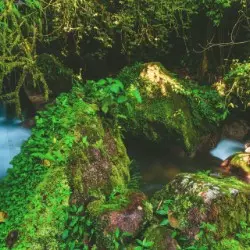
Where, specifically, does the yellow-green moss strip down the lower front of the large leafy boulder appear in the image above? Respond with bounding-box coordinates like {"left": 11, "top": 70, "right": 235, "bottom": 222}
{"left": 15, "top": 166, "right": 71, "bottom": 250}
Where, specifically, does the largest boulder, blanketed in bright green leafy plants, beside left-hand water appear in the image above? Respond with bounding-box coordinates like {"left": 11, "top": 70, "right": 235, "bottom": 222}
{"left": 0, "top": 87, "right": 130, "bottom": 250}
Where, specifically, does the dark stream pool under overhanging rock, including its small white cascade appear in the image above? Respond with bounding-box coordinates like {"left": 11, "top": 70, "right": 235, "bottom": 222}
{"left": 126, "top": 138, "right": 244, "bottom": 195}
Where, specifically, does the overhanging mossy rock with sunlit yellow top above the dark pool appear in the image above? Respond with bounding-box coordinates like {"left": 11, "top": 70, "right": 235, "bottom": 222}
{"left": 118, "top": 63, "right": 224, "bottom": 151}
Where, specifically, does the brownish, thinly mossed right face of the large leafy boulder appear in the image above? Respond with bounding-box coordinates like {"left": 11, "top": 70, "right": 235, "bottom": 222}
{"left": 68, "top": 117, "right": 130, "bottom": 202}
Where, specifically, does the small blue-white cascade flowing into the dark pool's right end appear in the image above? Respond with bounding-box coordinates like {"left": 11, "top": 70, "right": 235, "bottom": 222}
{"left": 210, "top": 139, "right": 244, "bottom": 160}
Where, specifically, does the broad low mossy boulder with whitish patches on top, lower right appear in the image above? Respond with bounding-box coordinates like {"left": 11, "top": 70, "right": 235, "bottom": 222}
{"left": 153, "top": 173, "right": 250, "bottom": 240}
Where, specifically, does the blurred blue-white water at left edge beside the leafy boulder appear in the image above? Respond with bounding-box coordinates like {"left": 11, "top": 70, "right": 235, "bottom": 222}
{"left": 0, "top": 104, "right": 31, "bottom": 178}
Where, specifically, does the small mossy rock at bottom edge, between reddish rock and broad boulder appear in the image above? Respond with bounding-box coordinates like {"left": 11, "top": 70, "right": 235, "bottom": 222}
{"left": 144, "top": 225, "right": 180, "bottom": 250}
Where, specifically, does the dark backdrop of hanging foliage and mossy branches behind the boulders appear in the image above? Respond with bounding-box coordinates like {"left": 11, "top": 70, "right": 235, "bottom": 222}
{"left": 0, "top": 0, "right": 250, "bottom": 113}
